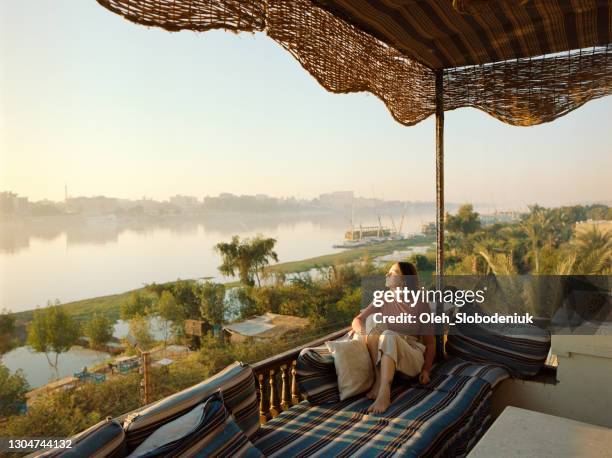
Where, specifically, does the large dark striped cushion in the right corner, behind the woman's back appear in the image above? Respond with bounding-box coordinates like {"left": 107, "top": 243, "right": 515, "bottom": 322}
{"left": 446, "top": 312, "right": 550, "bottom": 377}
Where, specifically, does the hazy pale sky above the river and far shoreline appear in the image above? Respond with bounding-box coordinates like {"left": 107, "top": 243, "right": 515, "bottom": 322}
{"left": 0, "top": 0, "right": 612, "bottom": 206}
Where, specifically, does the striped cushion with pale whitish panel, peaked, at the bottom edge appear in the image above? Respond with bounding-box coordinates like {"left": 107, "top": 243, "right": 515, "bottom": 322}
{"left": 130, "top": 393, "right": 263, "bottom": 458}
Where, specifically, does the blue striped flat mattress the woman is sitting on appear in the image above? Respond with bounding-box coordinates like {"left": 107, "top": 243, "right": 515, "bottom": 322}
{"left": 253, "top": 358, "right": 509, "bottom": 457}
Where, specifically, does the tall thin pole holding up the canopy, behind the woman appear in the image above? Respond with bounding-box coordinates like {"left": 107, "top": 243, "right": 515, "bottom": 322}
{"left": 436, "top": 70, "right": 444, "bottom": 360}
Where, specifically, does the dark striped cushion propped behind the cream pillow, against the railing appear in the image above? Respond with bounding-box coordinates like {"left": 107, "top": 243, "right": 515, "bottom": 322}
{"left": 296, "top": 346, "right": 340, "bottom": 405}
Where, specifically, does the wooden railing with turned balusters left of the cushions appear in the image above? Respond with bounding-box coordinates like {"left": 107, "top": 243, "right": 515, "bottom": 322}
{"left": 251, "top": 328, "right": 350, "bottom": 424}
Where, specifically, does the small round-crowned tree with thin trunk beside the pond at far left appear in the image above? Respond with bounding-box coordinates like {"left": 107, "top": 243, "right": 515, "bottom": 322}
{"left": 27, "top": 301, "right": 80, "bottom": 377}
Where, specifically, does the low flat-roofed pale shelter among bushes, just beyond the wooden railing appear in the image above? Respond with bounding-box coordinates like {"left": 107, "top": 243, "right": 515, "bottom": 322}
{"left": 223, "top": 312, "right": 309, "bottom": 343}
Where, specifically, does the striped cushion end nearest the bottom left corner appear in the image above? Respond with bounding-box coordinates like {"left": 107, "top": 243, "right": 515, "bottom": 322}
{"left": 30, "top": 419, "right": 125, "bottom": 458}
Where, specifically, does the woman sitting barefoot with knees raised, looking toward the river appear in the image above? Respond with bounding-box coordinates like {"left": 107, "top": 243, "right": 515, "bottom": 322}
{"left": 352, "top": 262, "right": 436, "bottom": 413}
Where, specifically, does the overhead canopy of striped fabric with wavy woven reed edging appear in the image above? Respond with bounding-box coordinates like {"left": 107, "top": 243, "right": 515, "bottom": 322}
{"left": 97, "top": 0, "right": 612, "bottom": 126}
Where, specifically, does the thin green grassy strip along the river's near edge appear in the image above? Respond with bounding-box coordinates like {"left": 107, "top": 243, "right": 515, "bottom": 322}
{"left": 14, "top": 237, "right": 433, "bottom": 325}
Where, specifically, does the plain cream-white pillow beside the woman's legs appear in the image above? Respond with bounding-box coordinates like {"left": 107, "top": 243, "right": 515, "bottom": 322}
{"left": 325, "top": 340, "right": 374, "bottom": 401}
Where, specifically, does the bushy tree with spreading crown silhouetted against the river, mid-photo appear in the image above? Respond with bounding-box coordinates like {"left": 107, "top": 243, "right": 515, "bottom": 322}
{"left": 215, "top": 235, "right": 278, "bottom": 286}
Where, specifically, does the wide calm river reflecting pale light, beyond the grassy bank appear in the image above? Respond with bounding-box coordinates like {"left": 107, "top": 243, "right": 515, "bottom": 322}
{"left": 0, "top": 210, "right": 434, "bottom": 312}
